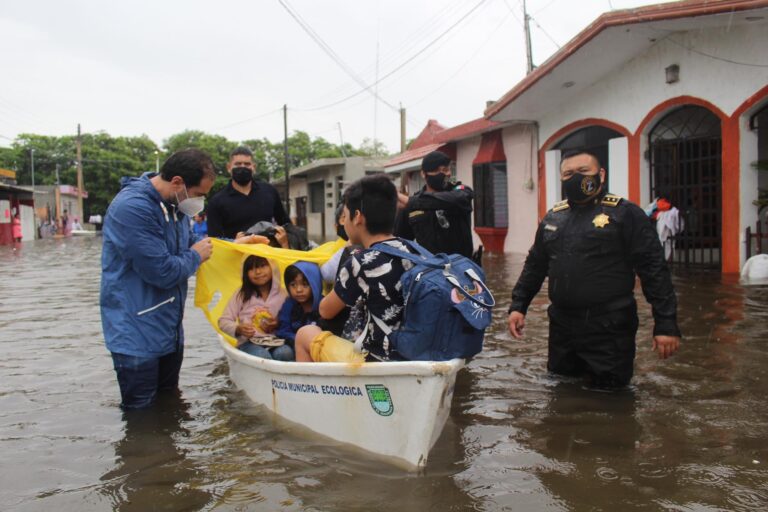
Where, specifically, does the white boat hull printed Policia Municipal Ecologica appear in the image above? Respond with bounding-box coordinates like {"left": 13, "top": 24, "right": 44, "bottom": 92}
{"left": 219, "top": 336, "right": 464, "bottom": 470}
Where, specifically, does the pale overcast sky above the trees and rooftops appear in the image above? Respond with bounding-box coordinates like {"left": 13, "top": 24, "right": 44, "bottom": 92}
{"left": 0, "top": 0, "right": 672, "bottom": 151}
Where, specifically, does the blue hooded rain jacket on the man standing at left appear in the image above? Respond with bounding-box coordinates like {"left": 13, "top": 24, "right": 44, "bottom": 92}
{"left": 100, "top": 173, "right": 200, "bottom": 357}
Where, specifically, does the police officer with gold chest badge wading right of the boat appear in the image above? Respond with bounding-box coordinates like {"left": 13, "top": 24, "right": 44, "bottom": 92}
{"left": 509, "top": 152, "right": 680, "bottom": 388}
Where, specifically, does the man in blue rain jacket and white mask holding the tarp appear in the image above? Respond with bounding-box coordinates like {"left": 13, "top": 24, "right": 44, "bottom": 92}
{"left": 100, "top": 149, "right": 216, "bottom": 409}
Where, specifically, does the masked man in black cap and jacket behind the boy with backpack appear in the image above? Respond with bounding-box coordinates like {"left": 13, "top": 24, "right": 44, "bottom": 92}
{"left": 395, "top": 151, "right": 475, "bottom": 258}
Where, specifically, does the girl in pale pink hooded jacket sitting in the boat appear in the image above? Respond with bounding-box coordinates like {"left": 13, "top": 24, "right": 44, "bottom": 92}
{"left": 219, "top": 255, "right": 294, "bottom": 361}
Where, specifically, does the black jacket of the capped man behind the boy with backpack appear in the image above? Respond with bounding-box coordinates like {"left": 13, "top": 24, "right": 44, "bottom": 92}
{"left": 395, "top": 184, "right": 475, "bottom": 258}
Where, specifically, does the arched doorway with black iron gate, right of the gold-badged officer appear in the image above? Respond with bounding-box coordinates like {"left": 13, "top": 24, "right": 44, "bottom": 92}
{"left": 649, "top": 105, "right": 722, "bottom": 268}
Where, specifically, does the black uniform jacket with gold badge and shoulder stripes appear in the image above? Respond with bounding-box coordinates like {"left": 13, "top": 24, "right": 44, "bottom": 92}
{"left": 510, "top": 194, "right": 680, "bottom": 336}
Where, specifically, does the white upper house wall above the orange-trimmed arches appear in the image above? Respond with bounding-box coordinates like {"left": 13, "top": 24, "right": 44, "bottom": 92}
{"left": 538, "top": 24, "right": 768, "bottom": 143}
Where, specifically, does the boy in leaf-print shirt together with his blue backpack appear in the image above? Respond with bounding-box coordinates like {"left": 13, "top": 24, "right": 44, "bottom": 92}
{"left": 296, "top": 174, "right": 494, "bottom": 362}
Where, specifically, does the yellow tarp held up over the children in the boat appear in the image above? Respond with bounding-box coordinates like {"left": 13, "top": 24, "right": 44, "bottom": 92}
{"left": 195, "top": 238, "right": 344, "bottom": 346}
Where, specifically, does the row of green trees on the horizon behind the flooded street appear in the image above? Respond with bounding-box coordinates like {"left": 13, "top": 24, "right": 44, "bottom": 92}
{"left": 0, "top": 130, "right": 387, "bottom": 218}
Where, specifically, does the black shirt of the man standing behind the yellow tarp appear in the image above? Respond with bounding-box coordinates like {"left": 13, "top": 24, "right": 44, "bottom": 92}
{"left": 208, "top": 181, "right": 290, "bottom": 238}
